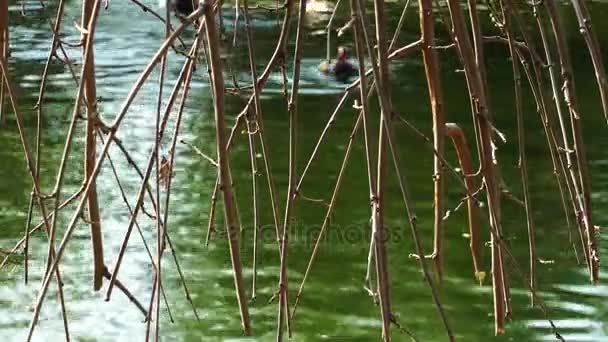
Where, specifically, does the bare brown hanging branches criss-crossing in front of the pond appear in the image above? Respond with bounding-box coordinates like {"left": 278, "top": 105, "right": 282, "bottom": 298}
{"left": 0, "top": 0, "right": 608, "bottom": 341}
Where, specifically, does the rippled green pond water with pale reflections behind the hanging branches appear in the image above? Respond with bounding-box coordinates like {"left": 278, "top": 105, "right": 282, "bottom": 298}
{"left": 0, "top": 0, "right": 608, "bottom": 341}
